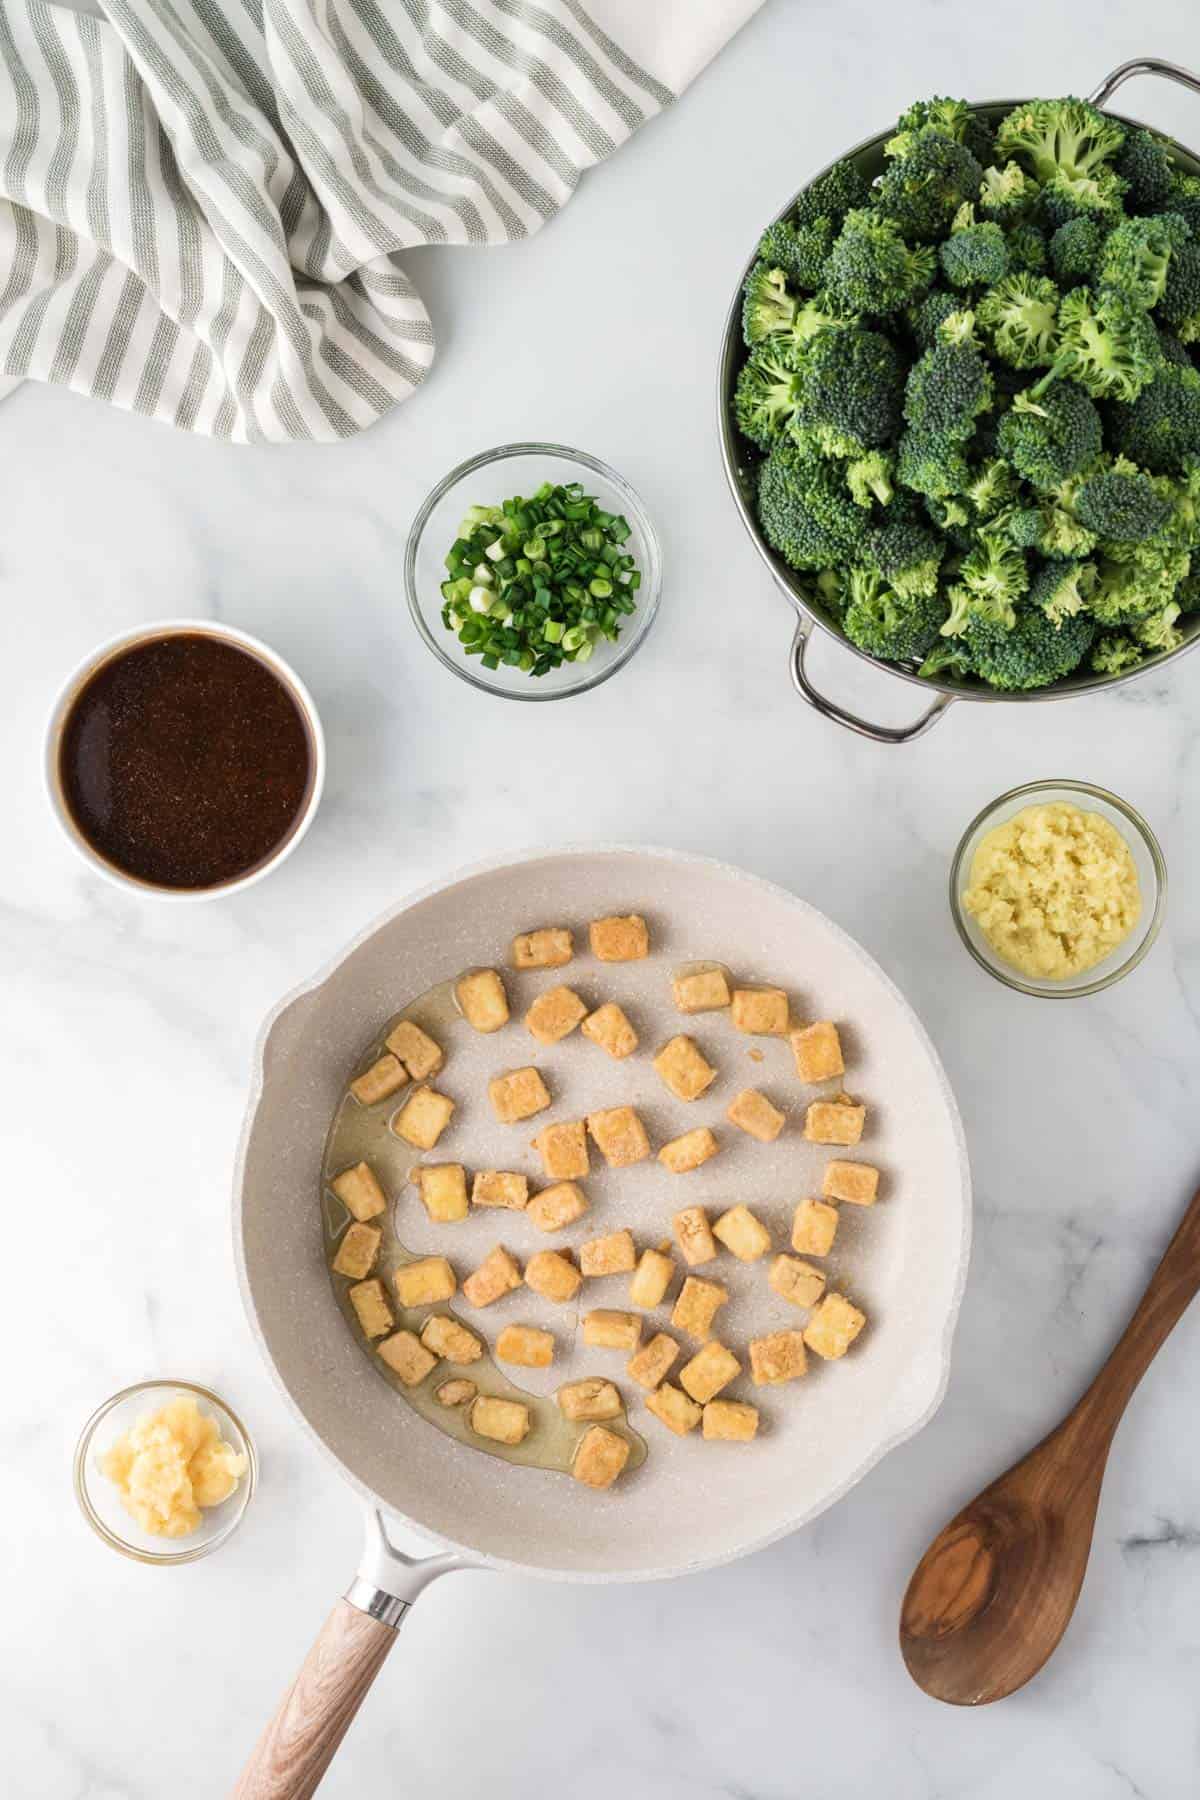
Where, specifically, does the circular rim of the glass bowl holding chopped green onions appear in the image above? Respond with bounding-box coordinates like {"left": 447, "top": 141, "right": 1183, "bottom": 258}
{"left": 405, "top": 439, "right": 662, "bottom": 702}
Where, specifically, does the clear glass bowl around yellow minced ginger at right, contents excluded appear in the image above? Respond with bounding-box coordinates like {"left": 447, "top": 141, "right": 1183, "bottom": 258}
{"left": 950, "top": 781, "right": 1166, "bottom": 1001}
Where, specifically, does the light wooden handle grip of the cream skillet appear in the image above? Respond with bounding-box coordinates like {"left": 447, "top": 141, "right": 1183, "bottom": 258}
{"left": 230, "top": 1600, "right": 396, "bottom": 1800}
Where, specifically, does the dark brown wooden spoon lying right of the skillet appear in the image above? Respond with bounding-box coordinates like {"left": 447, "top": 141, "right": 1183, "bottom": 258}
{"left": 900, "top": 1193, "right": 1200, "bottom": 1706}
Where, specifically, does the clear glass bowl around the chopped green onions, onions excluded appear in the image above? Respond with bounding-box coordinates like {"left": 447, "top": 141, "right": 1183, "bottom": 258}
{"left": 405, "top": 443, "right": 662, "bottom": 700}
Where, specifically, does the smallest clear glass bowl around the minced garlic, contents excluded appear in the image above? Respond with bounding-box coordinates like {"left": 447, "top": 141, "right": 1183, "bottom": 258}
{"left": 74, "top": 1381, "right": 259, "bottom": 1564}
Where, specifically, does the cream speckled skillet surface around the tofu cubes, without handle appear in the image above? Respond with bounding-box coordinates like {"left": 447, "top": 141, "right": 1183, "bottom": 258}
{"left": 236, "top": 850, "right": 970, "bottom": 1579}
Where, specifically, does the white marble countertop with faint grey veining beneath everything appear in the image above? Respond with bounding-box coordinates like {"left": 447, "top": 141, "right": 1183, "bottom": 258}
{"left": 0, "top": 0, "right": 1200, "bottom": 1800}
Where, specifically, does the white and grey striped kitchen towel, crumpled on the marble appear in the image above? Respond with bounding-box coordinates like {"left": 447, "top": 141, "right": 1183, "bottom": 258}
{"left": 0, "top": 0, "right": 761, "bottom": 443}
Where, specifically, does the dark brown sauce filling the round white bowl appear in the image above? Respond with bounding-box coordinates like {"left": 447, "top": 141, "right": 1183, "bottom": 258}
{"left": 59, "top": 632, "right": 313, "bottom": 889}
